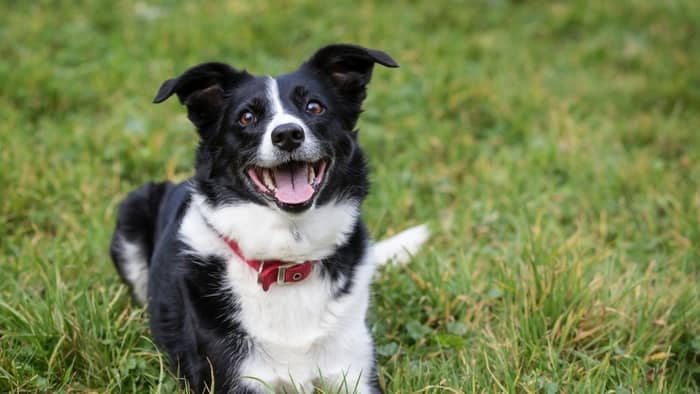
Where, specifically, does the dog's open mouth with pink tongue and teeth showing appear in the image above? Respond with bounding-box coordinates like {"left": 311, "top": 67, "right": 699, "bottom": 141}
{"left": 248, "top": 160, "right": 326, "bottom": 205}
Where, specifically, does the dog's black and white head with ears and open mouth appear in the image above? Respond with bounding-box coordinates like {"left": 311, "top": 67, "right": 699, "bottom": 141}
{"left": 154, "top": 45, "right": 397, "bottom": 213}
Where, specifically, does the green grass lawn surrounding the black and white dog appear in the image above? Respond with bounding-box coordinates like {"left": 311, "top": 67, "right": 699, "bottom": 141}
{"left": 0, "top": 0, "right": 700, "bottom": 393}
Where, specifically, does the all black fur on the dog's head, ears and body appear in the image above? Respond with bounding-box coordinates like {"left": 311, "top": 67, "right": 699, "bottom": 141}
{"left": 111, "top": 45, "right": 397, "bottom": 393}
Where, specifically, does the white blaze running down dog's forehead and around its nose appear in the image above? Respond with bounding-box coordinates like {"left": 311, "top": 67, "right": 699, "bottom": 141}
{"left": 259, "top": 77, "right": 316, "bottom": 162}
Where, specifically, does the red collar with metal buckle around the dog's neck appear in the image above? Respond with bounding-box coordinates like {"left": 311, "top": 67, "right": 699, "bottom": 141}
{"left": 223, "top": 237, "right": 315, "bottom": 291}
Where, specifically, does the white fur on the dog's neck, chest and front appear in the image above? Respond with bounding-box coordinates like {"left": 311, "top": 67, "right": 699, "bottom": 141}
{"left": 180, "top": 194, "right": 375, "bottom": 392}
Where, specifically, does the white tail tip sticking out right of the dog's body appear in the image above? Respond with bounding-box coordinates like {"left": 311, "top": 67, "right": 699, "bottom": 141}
{"left": 372, "top": 224, "right": 430, "bottom": 265}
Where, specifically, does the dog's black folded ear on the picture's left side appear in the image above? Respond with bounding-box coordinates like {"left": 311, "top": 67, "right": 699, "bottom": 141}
{"left": 153, "top": 62, "right": 250, "bottom": 130}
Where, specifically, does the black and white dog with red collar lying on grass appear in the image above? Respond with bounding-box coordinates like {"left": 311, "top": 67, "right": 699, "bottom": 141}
{"left": 111, "top": 45, "right": 428, "bottom": 393}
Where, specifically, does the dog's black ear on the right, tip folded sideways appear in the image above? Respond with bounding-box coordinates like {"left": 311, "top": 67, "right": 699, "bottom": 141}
{"left": 307, "top": 44, "right": 399, "bottom": 102}
